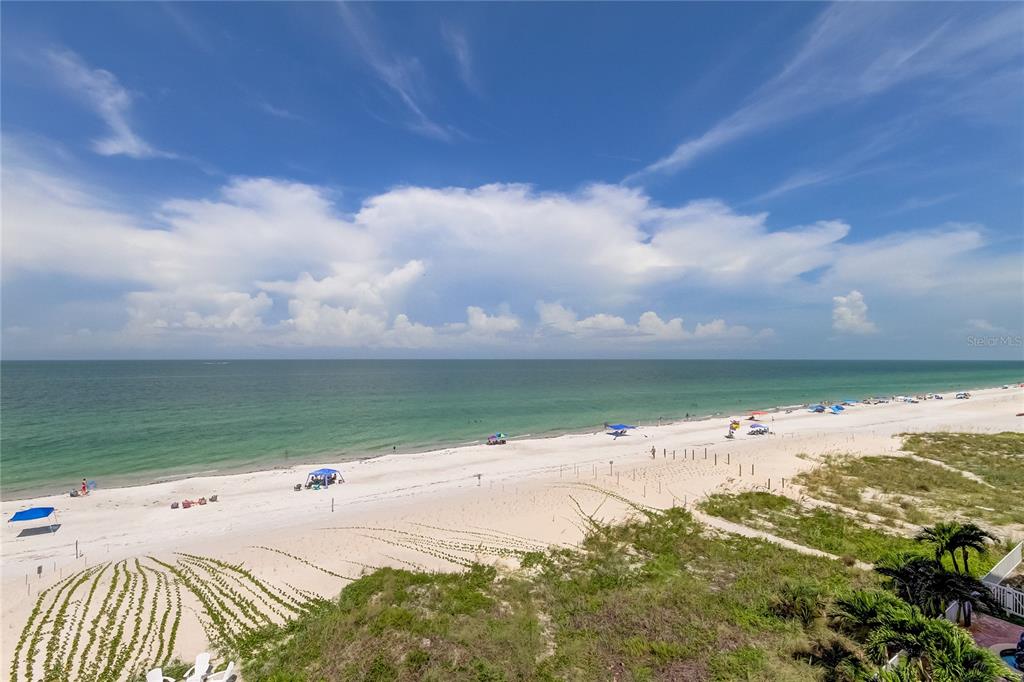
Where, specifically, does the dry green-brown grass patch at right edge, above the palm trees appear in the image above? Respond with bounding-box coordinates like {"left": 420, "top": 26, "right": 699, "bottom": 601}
{"left": 794, "top": 433, "right": 1024, "bottom": 530}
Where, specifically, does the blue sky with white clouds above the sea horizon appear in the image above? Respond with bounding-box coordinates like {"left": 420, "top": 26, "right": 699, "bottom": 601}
{"left": 0, "top": 2, "right": 1024, "bottom": 359}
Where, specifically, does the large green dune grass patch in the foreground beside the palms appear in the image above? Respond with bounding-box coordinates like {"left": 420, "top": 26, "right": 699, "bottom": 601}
{"left": 246, "top": 509, "right": 876, "bottom": 682}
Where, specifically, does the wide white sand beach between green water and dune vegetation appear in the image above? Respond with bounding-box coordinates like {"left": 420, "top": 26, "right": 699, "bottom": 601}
{"left": 0, "top": 387, "right": 1024, "bottom": 671}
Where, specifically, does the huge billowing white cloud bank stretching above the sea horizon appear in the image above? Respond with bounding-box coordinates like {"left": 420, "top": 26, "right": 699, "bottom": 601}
{"left": 2, "top": 146, "right": 1021, "bottom": 356}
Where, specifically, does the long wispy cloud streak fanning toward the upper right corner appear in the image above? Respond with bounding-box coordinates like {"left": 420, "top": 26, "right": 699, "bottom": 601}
{"left": 628, "top": 3, "right": 1022, "bottom": 179}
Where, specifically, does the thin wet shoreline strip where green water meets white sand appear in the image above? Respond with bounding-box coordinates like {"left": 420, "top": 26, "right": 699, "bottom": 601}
{"left": 0, "top": 376, "right": 1016, "bottom": 502}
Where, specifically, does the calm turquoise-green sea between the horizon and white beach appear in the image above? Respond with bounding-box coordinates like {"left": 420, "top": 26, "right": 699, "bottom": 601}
{"left": 0, "top": 360, "right": 1024, "bottom": 497}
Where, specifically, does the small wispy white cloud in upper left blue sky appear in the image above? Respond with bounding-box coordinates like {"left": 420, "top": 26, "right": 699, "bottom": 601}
{"left": 45, "top": 50, "right": 174, "bottom": 159}
